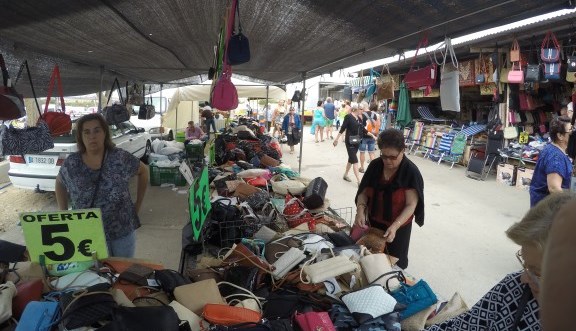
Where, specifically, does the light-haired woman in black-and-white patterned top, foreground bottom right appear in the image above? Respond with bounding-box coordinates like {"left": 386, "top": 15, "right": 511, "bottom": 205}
{"left": 426, "top": 193, "right": 575, "bottom": 331}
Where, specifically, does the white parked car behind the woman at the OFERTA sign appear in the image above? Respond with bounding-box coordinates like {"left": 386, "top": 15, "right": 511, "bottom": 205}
{"left": 8, "top": 121, "right": 152, "bottom": 192}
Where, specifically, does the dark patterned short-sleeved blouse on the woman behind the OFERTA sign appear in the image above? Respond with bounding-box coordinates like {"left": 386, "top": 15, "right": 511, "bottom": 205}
{"left": 60, "top": 148, "right": 140, "bottom": 240}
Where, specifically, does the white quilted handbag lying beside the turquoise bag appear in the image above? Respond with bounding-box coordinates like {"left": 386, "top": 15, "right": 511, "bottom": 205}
{"left": 340, "top": 285, "right": 402, "bottom": 324}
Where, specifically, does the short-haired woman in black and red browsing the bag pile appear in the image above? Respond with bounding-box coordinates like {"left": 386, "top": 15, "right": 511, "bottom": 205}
{"left": 355, "top": 129, "right": 424, "bottom": 268}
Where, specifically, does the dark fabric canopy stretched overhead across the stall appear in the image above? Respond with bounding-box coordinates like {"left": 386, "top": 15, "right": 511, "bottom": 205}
{"left": 0, "top": 0, "right": 569, "bottom": 97}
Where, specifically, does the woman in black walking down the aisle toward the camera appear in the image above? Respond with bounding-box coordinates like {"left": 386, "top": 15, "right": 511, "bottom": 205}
{"left": 334, "top": 105, "right": 376, "bottom": 185}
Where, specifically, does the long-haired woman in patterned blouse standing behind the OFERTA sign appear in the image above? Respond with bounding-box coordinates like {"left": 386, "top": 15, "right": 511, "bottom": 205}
{"left": 56, "top": 114, "right": 148, "bottom": 257}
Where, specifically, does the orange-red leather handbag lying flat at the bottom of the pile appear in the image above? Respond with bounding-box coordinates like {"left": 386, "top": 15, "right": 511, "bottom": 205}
{"left": 202, "top": 303, "right": 262, "bottom": 326}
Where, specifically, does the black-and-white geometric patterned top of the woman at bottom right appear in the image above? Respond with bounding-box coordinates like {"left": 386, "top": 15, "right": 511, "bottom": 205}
{"left": 426, "top": 272, "right": 542, "bottom": 331}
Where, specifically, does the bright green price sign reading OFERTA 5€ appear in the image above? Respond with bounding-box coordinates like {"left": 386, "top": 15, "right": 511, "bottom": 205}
{"left": 20, "top": 209, "right": 108, "bottom": 264}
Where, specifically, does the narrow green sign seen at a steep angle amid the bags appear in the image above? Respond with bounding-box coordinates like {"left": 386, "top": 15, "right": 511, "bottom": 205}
{"left": 188, "top": 167, "right": 212, "bottom": 241}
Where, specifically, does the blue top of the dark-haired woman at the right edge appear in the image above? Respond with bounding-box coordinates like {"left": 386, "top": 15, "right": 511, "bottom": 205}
{"left": 530, "top": 144, "right": 572, "bottom": 207}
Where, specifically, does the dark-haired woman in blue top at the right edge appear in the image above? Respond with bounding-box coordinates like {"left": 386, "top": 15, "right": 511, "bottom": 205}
{"left": 530, "top": 117, "right": 572, "bottom": 207}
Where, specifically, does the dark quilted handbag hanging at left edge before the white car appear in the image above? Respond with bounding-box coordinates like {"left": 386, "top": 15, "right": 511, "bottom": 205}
{"left": 0, "top": 120, "right": 54, "bottom": 155}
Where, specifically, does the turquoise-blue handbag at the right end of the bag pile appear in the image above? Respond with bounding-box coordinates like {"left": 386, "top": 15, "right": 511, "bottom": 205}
{"left": 390, "top": 279, "right": 438, "bottom": 320}
